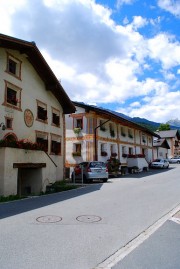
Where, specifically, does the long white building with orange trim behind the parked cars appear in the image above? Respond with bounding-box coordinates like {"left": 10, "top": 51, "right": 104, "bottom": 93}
{"left": 66, "top": 102, "right": 158, "bottom": 174}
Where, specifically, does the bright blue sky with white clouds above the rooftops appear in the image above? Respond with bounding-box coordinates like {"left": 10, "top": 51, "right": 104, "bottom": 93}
{"left": 0, "top": 0, "right": 180, "bottom": 123}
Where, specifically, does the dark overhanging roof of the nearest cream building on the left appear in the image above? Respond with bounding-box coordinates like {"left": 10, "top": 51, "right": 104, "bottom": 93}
{"left": 0, "top": 34, "right": 75, "bottom": 114}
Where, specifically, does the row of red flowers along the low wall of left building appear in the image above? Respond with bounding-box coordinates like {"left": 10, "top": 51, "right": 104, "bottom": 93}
{"left": 0, "top": 139, "right": 45, "bottom": 150}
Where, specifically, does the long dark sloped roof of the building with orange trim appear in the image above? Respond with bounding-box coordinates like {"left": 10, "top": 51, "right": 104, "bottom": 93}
{"left": 73, "top": 101, "right": 159, "bottom": 137}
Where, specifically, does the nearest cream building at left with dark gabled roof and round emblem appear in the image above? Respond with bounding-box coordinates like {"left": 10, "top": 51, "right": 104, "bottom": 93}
{"left": 0, "top": 34, "right": 75, "bottom": 195}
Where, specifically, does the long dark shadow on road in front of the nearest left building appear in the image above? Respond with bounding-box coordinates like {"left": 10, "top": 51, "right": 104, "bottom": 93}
{"left": 0, "top": 183, "right": 103, "bottom": 219}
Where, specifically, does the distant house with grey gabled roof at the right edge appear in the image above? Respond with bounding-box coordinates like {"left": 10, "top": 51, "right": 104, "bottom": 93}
{"left": 156, "top": 130, "right": 180, "bottom": 158}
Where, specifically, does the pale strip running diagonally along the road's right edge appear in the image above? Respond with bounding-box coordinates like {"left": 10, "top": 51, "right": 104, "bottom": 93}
{"left": 94, "top": 204, "right": 180, "bottom": 269}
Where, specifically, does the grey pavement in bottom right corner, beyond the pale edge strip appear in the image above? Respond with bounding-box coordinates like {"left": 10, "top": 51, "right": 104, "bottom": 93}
{"left": 111, "top": 211, "right": 180, "bottom": 269}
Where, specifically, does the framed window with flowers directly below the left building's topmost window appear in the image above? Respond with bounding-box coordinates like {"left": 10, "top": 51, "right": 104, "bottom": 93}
{"left": 3, "top": 81, "right": 21, "bottom": 109}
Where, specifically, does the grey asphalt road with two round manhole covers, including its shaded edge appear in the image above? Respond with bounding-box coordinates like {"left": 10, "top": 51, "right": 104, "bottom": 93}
{"left": 0, "top": 165, "right": 180, "bottom": 269}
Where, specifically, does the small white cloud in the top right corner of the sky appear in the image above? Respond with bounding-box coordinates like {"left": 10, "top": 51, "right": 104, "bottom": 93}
{"left": 158, "top": 0, "right": 180, "bottom": 18}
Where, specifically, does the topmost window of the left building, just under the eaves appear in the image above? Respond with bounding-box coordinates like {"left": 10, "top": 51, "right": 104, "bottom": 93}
{"left": 6, "top": 53, "right": 21, "bottom": 79}
